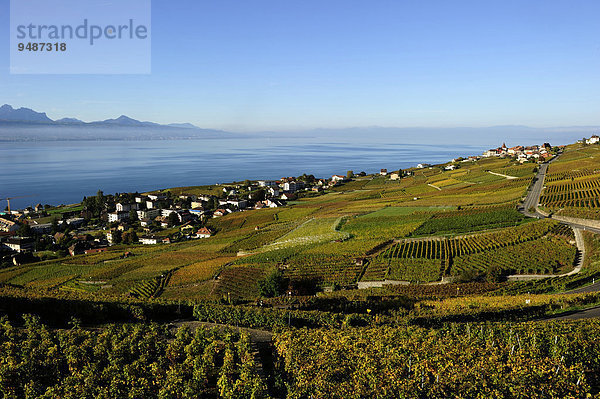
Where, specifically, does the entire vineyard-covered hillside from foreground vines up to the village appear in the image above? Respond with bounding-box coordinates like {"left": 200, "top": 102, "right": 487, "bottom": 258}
{"left": 5, "top": 144, "right": 600, "bottom": 398}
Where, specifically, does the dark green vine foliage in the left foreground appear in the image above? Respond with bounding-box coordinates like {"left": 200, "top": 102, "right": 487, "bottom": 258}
{"left": 0, "top": 316, "right": 268, "bottom": 399}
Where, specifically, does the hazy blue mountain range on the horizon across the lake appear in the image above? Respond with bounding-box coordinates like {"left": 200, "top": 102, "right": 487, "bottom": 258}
{"left": 0, "top": 104, "right": 600, "bottom": 145}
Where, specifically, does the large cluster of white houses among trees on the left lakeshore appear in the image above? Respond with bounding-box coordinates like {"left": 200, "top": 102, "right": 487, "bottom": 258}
{"left": 0, "top": 175, "right": 360, "bottom": 256}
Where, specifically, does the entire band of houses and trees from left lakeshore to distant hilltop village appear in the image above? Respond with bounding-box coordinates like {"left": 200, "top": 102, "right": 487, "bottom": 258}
{"left": 0, "top": 135, "right": 580, "bottom": 266}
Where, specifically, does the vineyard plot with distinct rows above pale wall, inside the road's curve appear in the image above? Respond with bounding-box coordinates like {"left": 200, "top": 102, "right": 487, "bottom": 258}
{"left": 363, "top": 219, "right": 576, "bottom": 282}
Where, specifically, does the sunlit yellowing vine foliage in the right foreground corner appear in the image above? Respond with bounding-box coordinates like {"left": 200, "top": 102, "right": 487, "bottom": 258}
{"left": 275, "top": 320, "right": 600, "bottom": 399}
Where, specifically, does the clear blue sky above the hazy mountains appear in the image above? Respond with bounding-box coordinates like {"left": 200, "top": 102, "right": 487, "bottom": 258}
{"left": 0, "top": 0, "right": 600, "bottom": 131}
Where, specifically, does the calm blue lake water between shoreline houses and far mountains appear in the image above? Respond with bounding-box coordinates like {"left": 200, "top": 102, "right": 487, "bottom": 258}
{"left": 0, "top": 138, "right": 485, "bottom": 209}
